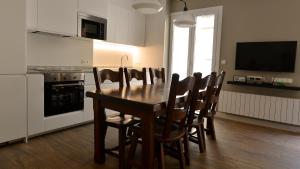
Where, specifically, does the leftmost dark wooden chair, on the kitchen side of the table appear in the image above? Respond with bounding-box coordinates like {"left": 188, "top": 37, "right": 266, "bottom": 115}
{"left": 93, "top": 67, "right": 136, "bottom": 168}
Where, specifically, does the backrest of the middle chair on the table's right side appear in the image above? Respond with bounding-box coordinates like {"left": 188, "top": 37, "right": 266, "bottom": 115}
{"left": 187, "top": 72, "right": 216, "bottom": 126}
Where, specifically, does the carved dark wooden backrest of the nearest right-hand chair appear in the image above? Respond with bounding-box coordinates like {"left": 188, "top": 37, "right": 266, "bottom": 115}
{"left": 163, "top": 74, "right": 195, "bottom": 138}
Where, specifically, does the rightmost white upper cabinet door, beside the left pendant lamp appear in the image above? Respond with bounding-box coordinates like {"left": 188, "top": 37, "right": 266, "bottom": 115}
{"left": 128, "top": 9, "right": 145, "bottom": 46}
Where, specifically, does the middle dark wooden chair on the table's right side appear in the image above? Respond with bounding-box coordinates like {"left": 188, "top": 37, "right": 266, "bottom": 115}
{"left": 187, "top": 72, "right": 216, "bottom": 153}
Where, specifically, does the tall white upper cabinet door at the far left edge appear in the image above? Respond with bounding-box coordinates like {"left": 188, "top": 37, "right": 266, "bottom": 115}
{"left": 0, "top": 0, "right": 26, "bottom": 74}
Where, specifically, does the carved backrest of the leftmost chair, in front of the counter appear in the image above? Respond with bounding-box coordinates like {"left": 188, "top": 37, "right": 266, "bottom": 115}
{"left": 93, "top": 67, "right": 123, "bottom": 91}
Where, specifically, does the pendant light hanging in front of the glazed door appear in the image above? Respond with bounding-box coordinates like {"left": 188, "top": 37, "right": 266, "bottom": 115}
{"left": 174, "top": 0, "right": 196, "bottom": 28}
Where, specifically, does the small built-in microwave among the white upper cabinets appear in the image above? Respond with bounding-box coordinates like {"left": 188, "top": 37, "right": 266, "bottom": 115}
{"left": 78, "top": 13, "right": 107, "bottom": 40}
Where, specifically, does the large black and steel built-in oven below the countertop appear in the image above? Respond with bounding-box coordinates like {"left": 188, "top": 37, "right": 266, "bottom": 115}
{"left": 44, "top": 73, "right": 84, "bottom": 117}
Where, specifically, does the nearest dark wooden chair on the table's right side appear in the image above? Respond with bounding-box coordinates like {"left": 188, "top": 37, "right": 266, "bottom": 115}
{"left": 128, "top": 74, "right": 195, "bottom": 169}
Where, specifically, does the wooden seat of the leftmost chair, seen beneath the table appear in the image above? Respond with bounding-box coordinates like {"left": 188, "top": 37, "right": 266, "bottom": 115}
{"left": 106, "top": 115, "right": 140, "bottom": 128}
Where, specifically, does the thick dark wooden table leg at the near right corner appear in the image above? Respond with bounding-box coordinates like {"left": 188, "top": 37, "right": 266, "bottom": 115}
{"left": 142, "top": 113, "right": 155, "bottom": 169}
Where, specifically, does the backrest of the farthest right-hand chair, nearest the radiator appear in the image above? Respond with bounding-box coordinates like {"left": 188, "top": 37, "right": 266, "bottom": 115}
{"left": 211, "top": 71, "right": 226, "bottom": 113}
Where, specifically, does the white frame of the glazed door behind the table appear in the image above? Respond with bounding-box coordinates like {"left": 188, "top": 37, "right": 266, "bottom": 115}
{"left": 168, "top": 6, "right": 223, "bottom": 78}
